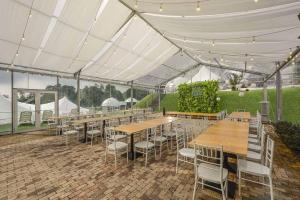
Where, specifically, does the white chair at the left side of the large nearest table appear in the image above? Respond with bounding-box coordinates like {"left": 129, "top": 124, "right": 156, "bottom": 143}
{"left": 175, "top": 128, "right": 195, "bottom": 174}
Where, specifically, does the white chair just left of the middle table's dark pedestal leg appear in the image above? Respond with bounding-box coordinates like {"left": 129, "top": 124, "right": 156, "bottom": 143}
{"left": 105, "top": 129, "right": 128, "bottom": 168}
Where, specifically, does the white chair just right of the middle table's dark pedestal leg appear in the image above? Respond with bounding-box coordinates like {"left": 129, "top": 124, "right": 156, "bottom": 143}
{"left": 134, "top": 128, "right": 156, "bottom": 167}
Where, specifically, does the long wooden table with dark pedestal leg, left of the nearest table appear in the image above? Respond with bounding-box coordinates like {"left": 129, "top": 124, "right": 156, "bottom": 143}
{"left": 114, "top": 117, "right": 177, "bottom": 160}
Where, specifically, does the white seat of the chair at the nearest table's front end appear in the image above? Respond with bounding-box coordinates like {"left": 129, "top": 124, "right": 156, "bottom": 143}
{"left": 198, "top": 163, "right": 228, "bottom": 183}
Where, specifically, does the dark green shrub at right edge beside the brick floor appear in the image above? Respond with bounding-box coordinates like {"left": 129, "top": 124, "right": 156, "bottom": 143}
{"left": 275, "top": 121, "right": 300, "bottom": 151}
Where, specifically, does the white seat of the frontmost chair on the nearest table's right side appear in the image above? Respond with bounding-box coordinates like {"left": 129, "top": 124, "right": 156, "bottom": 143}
{"left": 238, "top": 159, "right": 270, "bottom": 176}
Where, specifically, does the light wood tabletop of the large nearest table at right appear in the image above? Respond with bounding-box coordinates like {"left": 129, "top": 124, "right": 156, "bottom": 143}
{"left": 189, "top": 119, "right": 249, "bottom": 156}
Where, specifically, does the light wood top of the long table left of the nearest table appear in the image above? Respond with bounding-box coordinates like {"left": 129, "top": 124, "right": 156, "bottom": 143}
{"left": 114, "top": 117, "right": 177, "bottom": 135}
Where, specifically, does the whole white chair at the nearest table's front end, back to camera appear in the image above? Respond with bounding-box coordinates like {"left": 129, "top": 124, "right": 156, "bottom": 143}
{"left": 193, "top": 145, "right": 228, "bottom": 200}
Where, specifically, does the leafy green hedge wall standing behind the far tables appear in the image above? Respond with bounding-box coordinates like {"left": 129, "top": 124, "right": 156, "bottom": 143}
{"left": 178, "top": 81, "right": 220, "bottom": 113}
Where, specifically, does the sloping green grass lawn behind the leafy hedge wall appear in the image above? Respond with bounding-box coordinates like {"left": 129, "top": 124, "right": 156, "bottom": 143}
{"left": 161, "top": 87, "right": 300, "bottom": 124}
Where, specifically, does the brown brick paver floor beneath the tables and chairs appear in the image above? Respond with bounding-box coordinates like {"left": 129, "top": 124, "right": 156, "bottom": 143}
{"left": 0, "top": 126, "right": 300, "bottom": 200}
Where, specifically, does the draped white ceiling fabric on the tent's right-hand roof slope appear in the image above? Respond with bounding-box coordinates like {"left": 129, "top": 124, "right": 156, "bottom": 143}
{"left": 124, "top": 0, "right": 300, "bottom": 76}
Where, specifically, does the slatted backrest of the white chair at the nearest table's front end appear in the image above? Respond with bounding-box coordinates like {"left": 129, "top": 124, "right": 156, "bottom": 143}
{"left": 194, "top": 145, "right": 223, "bottom": 182}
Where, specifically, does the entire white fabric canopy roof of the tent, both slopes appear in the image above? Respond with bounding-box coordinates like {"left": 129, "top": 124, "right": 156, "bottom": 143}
{"left": 0, "top": 0, "right": 300, "bottom": 86}
